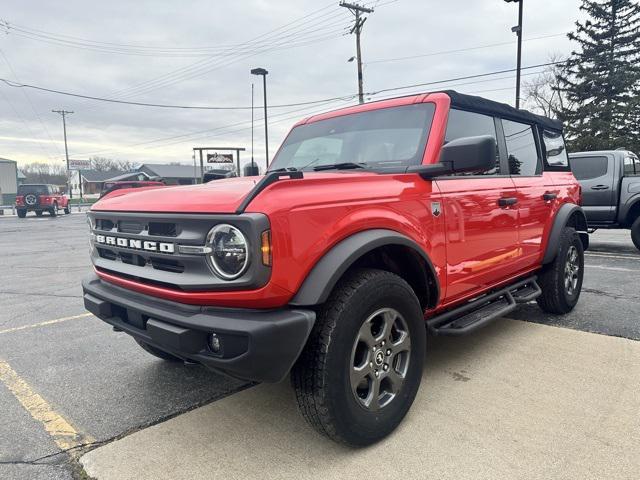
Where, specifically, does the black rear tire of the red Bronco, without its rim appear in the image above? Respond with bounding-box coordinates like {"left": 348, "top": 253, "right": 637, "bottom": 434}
{"left": 536, "top": 227, "right": 584, "bottom": 315}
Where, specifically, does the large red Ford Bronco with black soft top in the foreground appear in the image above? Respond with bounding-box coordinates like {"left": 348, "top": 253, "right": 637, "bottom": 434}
{"left": 83, "top": 92, "right": 589, "bottom": 446}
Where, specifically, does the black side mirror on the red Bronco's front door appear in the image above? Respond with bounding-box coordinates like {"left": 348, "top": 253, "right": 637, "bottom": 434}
{"left": 407, "top": 135, "right": 496, "bottom": 179}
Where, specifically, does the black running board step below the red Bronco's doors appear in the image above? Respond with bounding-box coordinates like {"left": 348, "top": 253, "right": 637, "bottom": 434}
{"left": 427, "top": 276, "right": 542, "bottom": 336}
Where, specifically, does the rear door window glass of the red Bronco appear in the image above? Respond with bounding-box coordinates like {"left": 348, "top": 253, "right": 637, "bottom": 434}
{"left": 502, "top": 120, "right": 541, "bottom": 177}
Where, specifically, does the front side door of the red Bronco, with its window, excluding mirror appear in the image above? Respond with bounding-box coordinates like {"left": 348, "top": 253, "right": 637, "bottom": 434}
{"left": 436, "top": 109, "right": 522, "bottom": 303}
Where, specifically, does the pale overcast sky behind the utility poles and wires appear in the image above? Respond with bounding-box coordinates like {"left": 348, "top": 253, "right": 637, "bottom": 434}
{"left": 0, "top": 0, "right": 580, "bottom": 170}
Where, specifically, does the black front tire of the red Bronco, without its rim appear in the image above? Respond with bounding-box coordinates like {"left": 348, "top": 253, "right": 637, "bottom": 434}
{"left": 291, "top": 269, "right": 426, "bottom": 446}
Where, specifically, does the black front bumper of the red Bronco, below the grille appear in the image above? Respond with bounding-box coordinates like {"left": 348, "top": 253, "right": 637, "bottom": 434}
{"left": 82, "top": 274, "right": 315, "bottom": 382}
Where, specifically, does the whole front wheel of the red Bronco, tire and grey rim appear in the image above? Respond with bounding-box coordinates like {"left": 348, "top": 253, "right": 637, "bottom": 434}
{"left": 291, "top": 269, "right": 426, "bottom": 446}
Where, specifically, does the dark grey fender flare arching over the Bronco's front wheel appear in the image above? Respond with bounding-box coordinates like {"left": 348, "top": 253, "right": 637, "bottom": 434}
{"left": 289, "top": 229, "right": 440, "bottom": 306}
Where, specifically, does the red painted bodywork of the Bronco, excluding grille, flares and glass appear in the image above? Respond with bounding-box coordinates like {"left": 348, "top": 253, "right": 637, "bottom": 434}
{"left": 93, "top": 93, "right": 579, "bottom": 313}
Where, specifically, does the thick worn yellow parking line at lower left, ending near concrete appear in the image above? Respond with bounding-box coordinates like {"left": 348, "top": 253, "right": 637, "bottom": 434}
{"left": 0, "top": 360, "right": 93, "bottom": 455}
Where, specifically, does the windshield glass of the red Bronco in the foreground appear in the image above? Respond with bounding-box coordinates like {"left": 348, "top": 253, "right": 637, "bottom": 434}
{"left": 269, "top": 103, "right": 435, "bottom": 170}
